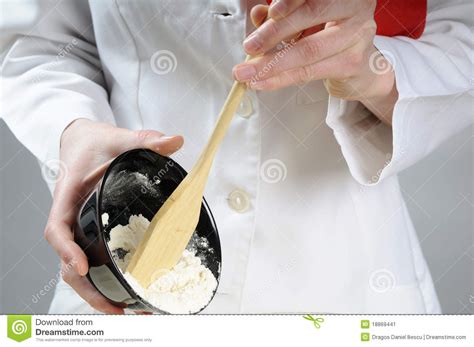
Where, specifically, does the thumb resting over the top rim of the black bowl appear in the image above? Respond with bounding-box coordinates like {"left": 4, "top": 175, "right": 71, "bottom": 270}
{"left": 112, "top": 128, "right": 184, "bottom": 155}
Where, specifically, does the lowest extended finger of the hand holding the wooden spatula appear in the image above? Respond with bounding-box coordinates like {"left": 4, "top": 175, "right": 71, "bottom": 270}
{"left": 249, "top": 47, "right": 363, "bottom": 90}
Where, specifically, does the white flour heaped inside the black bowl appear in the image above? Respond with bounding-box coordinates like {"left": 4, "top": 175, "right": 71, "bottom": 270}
{"left": 102, "top": 213, "right": 217, "bottom": 314}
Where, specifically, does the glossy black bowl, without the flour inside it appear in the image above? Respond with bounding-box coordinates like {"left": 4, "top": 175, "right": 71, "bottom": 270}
{"left": 74, "top": 149, "right": 222, "bottom": 314}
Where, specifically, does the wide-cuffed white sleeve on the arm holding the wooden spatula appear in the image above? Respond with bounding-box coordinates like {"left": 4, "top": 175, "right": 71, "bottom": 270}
{"left": 327, "top": 0, "right": 474, "bottom": 185}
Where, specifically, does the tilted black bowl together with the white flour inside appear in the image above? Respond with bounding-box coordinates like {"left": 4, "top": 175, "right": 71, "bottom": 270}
{"left": 74, "top": 149, "right": 222, "bottom": 314}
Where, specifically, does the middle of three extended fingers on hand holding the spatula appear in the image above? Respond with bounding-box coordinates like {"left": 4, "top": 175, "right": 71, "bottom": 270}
{"left": 233, "top": 25, "right": 358, "bottom": 82}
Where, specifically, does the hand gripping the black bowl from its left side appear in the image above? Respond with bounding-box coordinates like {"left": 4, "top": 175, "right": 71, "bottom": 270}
{"left": 45, "top": 119, "right": 183, "bottom": 314}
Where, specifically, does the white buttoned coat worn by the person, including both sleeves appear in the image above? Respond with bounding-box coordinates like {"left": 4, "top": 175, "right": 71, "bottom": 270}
{"left": 2, "top": 0, "right": 473, "bottom": 313}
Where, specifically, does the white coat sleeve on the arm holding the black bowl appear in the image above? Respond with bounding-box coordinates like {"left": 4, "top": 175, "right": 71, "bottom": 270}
{"left": 0, "top": 0, "right": 114, "bottom": 169}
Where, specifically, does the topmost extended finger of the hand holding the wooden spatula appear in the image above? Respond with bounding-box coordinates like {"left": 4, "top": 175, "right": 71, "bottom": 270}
{"left": 244, "top": 0, "right": 360, "bottom": 55}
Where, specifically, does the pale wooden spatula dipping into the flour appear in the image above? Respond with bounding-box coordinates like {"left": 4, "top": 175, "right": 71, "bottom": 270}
{"left": 127, "top": 56, "right": 250, "bottom": 288}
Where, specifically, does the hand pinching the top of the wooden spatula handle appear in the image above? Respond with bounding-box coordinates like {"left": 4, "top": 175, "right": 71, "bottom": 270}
{"left": 233, "top": 0, "right": 398, "bottom": 123}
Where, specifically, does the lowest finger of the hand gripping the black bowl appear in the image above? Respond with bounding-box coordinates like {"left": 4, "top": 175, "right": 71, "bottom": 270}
{"left": 62, "top": 267, "right": 124, "bottom": 314}
